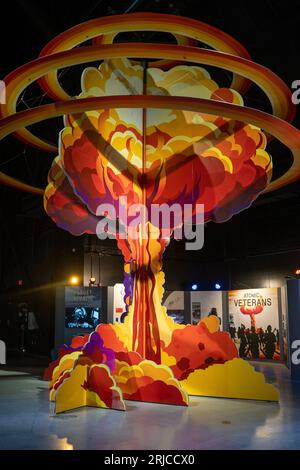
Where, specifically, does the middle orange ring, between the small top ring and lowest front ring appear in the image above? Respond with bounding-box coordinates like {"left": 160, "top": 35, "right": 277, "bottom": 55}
{"left": 0, "top": 43, "right": 295, "bottom": 152}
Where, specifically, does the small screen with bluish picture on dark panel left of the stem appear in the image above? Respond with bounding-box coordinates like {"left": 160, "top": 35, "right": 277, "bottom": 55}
{"left": 65, "top": 306, "right": 101, "bottom": 328}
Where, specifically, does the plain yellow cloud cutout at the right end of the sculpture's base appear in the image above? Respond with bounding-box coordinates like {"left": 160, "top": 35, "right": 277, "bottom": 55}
{"left": 181, "top": 359, "right": 279, "bottom": 401}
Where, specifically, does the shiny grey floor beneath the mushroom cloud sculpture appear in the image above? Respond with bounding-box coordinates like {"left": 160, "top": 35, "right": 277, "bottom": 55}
{"left": 0, "top": 364, "right": 300, "bottom": 450}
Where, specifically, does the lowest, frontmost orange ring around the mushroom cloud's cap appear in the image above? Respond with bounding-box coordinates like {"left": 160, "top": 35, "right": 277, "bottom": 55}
{"left": 0, "top": 95, "right": 300, "bottom": 194}
